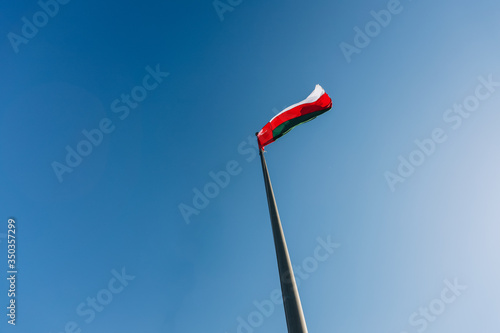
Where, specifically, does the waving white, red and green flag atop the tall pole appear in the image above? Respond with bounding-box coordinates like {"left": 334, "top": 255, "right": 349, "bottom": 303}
{"left": 257, "top": 84, "right": 332, "bottom": 149}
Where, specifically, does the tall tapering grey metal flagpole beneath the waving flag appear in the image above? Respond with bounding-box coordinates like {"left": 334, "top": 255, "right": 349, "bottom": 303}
{"left": 259, "top": 145, "right": 308, "bottom": 333}
